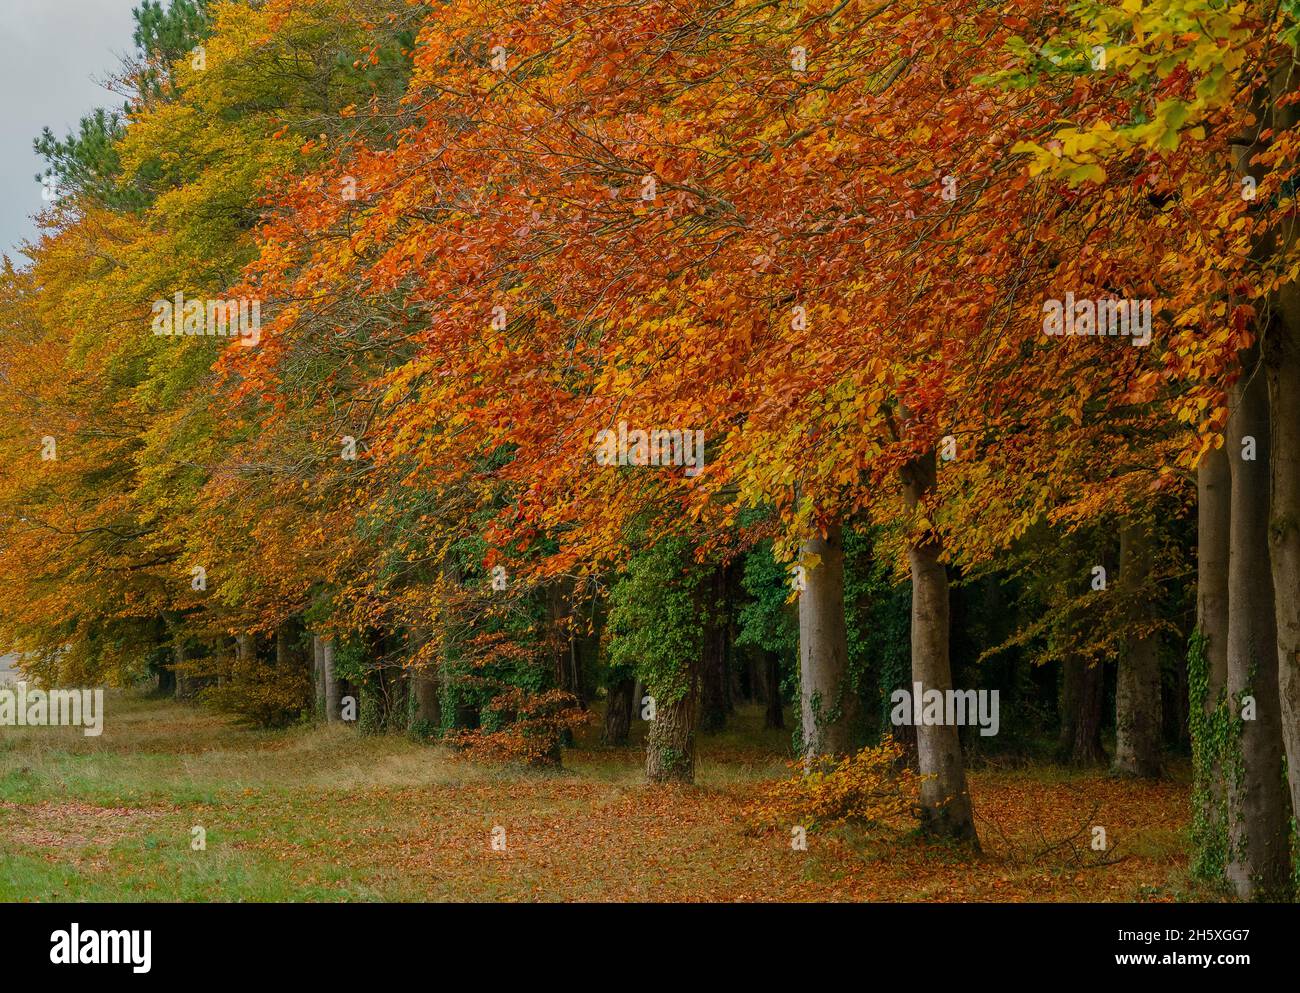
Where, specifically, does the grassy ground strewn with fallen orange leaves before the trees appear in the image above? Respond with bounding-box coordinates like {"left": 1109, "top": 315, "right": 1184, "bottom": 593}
{"left": 0, "top": 693, "right": 1206, "bottom": 902}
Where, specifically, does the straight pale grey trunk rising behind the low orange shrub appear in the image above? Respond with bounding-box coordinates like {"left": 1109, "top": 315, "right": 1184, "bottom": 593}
{"left": 800, "top": 525, "right": 858, "bottom": 759}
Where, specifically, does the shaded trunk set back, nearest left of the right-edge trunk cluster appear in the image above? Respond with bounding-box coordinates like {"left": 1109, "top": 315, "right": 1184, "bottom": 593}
{"left": 1114, "top": 521, "right": 1161, "bottom": 777}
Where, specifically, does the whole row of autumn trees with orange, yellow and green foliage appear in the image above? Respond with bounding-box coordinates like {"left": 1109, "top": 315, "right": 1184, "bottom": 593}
{"left": 0, "top": 0, "right": 1300, "bottom": 898}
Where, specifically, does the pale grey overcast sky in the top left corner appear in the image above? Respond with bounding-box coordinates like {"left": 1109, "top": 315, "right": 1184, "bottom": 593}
{"left": 0, "top": 0, "right": 139, "bottom": 261}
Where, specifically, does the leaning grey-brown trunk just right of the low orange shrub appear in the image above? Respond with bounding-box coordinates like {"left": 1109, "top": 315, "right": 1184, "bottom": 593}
{"left": 902, "top": 452, "right": 979, "bottom": 847}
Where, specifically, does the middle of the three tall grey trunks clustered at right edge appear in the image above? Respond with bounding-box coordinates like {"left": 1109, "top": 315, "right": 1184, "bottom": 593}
{"left": 1227, "top": 357, "right": 1291, "bottom": 899}
